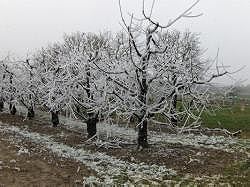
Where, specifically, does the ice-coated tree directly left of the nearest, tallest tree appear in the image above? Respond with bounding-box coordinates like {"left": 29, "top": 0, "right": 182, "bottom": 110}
{"left": 63, "top": 32, "right": 109, "bottom": 138}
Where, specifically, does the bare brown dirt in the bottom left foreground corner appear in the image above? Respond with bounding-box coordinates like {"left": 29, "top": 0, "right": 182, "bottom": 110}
{"left": 0, "top": 134, "right": 95, "bottom": 187}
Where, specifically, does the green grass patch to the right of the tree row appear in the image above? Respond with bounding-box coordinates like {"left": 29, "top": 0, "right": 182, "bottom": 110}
{"left": 202, "top": 103, "right": 250, "bottom": 132}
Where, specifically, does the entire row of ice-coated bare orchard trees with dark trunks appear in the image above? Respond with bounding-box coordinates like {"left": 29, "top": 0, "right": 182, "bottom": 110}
{"left": 0, "top": 0, "right": 233, "bottom": 148}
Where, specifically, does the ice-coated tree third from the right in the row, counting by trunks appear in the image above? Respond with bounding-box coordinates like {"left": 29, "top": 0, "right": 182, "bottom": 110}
{"left": 32, "top": 44, "right": 66, "bottom": 126}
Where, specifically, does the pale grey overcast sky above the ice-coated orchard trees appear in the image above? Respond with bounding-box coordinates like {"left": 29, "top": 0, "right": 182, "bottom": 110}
{"left": 0, "top": 0, "right": 250, "bottom": 84}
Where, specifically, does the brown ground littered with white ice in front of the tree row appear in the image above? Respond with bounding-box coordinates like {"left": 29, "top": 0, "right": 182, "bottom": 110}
{"left": 0, "top": 113, "right": 250, "bottom": 186}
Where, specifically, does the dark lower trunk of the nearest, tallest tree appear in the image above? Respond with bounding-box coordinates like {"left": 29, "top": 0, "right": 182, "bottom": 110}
{"left": 137, "top": 120, "right": 149, "bottom": 148}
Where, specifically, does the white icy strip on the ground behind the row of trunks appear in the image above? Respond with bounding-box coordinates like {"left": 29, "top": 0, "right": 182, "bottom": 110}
{"left": 17, "top": 106, "right": 238, "bottom": 151}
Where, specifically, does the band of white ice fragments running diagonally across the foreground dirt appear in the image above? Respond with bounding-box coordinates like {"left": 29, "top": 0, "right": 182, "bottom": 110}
{"left": 0, "top": 123, "right": 176, "bottom": 184}
